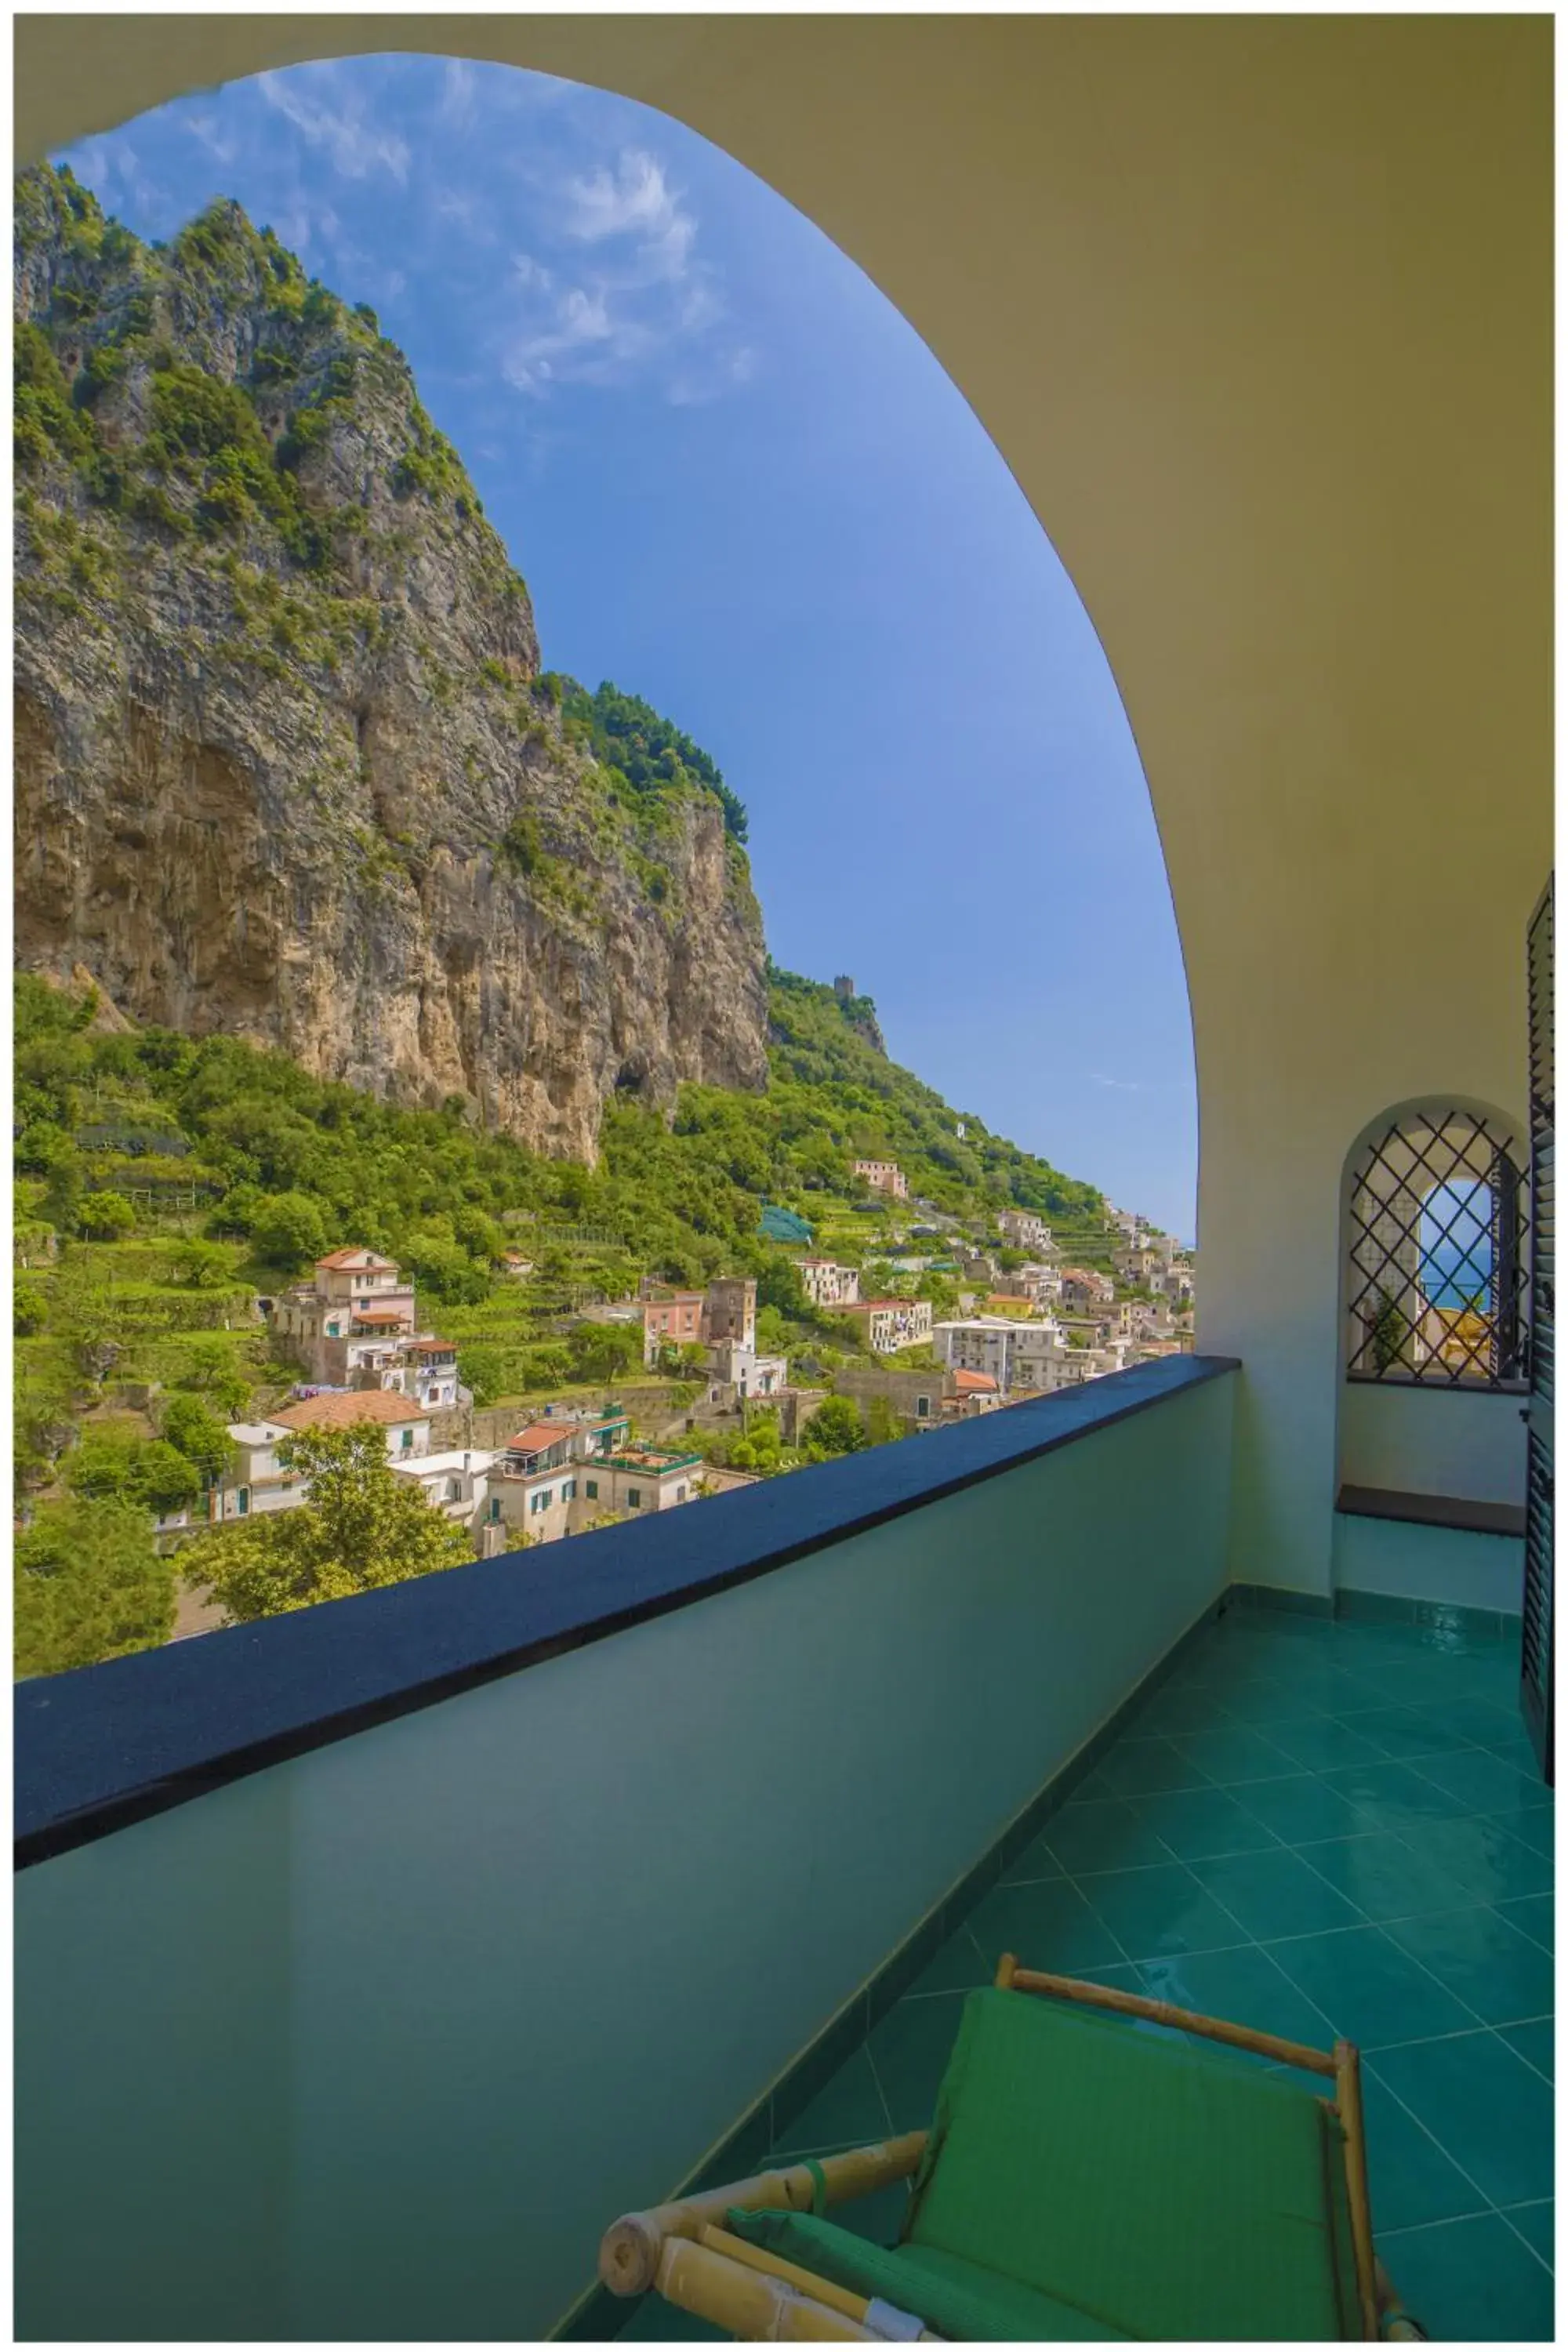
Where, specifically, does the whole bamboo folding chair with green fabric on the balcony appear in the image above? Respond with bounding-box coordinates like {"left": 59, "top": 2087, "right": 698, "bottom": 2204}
{"left": 600, "top": 1952, "right": 1425, "bottom": 2343}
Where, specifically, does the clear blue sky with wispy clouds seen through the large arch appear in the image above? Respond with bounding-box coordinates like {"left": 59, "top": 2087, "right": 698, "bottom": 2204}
{"left": 61, "top": 56, "right": 1196, "bottom": 1237}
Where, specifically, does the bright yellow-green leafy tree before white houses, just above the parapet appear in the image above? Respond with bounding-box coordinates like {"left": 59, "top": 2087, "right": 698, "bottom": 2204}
{"left": 181, "top": 1423, "right": 473, "bottom": 1625}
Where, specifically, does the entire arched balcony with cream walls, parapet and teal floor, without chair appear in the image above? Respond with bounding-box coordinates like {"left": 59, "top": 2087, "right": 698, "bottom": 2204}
{"left": 14, "top": 14, "right": 1554, "bottom": 2340}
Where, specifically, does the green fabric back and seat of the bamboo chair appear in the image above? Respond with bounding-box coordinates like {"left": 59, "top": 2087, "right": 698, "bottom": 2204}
{"left": 731, "top": 1990, "right": 1361, "bottom": 2343}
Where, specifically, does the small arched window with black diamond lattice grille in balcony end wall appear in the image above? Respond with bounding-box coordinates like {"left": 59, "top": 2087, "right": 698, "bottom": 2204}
{"left": 1347, "top": 1110, "right": 1526, "bottom": 1388}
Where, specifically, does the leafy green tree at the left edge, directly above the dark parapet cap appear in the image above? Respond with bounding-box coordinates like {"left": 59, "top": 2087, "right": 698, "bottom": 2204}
{"left": 14, "top": 1501, "right": 174, "bottom": 1677}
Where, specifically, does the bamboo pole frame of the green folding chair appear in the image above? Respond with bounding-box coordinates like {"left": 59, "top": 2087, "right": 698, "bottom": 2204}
{"left": 600, "top": 1952, "right": 1425, "bottom": 2343}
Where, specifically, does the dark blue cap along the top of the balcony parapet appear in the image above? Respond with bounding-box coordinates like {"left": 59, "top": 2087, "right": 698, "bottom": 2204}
{"left": 16, "top": 1357, "right": 1239, "bottom": 1867}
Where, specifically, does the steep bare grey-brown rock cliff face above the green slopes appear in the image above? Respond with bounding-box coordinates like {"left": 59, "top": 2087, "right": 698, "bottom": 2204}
{"left": 14, "top": 169, "right": 767, "bottom": 1160}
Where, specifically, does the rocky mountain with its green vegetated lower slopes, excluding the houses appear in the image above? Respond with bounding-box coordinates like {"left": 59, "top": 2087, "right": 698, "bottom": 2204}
{"left": 14, "top": 167, "right": 1105, "bottom": 1675}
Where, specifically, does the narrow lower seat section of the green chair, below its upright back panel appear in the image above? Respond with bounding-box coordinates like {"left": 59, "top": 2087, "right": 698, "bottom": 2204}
{"left": 727, "top": 2211, "right": 1121, "bottom": 2343}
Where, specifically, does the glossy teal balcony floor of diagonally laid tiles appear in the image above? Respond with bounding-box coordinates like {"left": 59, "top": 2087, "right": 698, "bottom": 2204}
{"left": 626, "top": 1611, "right": 1554, "bottom": 2340}
